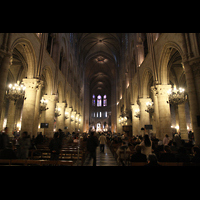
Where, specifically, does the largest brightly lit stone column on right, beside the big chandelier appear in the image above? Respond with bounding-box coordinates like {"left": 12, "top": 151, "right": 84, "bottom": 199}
{"left": 156, "top": 85, "right": 171, "bottom": 139}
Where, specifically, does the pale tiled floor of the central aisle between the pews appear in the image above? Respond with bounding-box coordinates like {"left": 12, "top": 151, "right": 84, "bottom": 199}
{"left": 83, "top": 145, "right": 118, "bottom": 166}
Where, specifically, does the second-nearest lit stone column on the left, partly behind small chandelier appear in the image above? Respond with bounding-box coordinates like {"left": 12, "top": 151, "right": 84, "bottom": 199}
{"left": 44, "top": 95, "right": 57, "bottom": 138}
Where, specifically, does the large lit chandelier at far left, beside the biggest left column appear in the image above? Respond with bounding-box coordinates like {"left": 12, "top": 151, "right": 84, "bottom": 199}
{"left": 6, "top": 81, "right": 26, "bottom": 104}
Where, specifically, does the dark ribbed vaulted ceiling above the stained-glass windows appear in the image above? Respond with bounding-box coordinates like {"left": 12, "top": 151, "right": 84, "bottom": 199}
{"left": 77, "top": 33, "right": 121, "bottom": 95}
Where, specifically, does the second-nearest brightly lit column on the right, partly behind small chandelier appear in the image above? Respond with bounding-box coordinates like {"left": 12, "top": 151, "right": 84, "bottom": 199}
{"left": 139, "top": 98, "right": 151, "bottom": 129}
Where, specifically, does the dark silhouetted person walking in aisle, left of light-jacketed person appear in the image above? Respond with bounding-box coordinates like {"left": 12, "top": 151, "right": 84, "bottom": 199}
{"left": 87, "top": 132, "right": 99, "bottom": 166}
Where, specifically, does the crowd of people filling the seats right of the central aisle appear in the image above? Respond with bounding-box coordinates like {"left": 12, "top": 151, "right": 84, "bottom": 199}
{"left": 110, "top": 132, "right": 200, "bottom": 166}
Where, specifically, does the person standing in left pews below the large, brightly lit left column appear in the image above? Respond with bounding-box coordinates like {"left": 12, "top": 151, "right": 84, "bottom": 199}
{"left": 19, "top": 131, "right": 31, "bottom": 159}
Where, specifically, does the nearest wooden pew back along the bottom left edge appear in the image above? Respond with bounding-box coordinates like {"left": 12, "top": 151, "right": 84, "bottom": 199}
{"left": 0, "top": 159, "right": 73, "bottom": 166}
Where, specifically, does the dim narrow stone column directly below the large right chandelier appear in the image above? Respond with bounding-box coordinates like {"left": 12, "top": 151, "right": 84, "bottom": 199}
{"left": 178, "top": 103, "right": 188, "bottom": 140}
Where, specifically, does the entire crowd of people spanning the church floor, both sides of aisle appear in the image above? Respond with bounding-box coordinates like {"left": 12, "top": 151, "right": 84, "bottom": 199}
{"left": 0, "top": 127, "right": 200, "bottom": 166}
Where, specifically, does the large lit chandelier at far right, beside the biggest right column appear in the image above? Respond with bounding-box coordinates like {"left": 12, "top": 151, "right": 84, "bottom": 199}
{"left": 167, "top": 85, "right": 187, "bottom": 104}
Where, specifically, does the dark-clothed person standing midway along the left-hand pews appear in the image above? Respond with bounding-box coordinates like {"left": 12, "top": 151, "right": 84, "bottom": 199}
{"left": 49, "top": 132, "right": 62, "bottom": 160}
